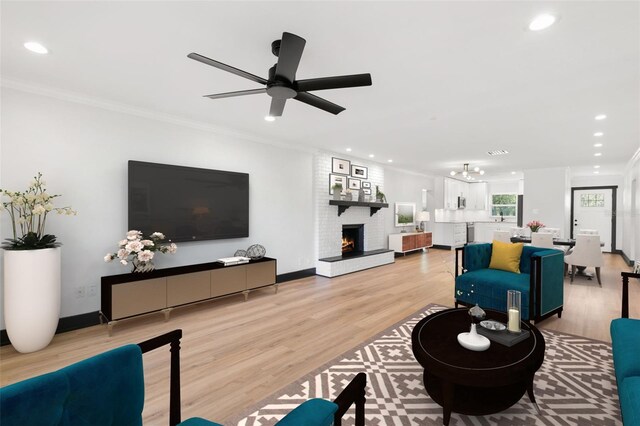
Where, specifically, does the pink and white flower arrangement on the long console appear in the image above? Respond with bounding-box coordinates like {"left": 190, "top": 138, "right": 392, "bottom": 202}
{"left": 104, "top": 230, "right": 178, "bottom": 272}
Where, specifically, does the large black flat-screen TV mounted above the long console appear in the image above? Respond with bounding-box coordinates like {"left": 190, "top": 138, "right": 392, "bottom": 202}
{"left": 129, "top": 161, "right": 249, "bottom": 242}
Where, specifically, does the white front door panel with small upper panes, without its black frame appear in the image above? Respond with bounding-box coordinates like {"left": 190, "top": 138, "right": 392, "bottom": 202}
{"left": 573, "top": 188, "right": 613, "bottom": 252}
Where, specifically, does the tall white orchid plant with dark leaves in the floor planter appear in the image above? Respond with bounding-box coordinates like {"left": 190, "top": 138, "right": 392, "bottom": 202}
{"left": 0, "top": 173, "right": 77, "bottom": 250}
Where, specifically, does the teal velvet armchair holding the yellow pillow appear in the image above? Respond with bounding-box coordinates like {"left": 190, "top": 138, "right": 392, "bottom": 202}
{"left": 454, "top": 243, "right": 564, "bottom": 322}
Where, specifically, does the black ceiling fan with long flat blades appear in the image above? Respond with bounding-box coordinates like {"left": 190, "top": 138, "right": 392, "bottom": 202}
{"left": 187, "top": 32, "right": 371, "bottom": 117}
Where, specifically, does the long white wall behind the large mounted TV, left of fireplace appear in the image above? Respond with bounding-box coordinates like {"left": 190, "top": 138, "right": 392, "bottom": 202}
{"left": 0, "top": 88, "right": 315, "bottom": 328}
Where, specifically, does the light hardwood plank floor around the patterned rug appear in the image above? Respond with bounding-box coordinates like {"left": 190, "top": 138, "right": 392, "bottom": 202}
{"left": 0, "top": 249, "right": 640, "bottom": 425}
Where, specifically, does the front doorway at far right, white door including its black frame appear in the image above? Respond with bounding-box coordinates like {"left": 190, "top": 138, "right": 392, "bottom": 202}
{"left": 571, "top": 186, "right": 618, "bottom": 252}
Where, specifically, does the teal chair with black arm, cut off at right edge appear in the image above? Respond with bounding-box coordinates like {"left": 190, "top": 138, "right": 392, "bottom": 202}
{"left": 611, "top": 272, "right": 640, "bottom": 426}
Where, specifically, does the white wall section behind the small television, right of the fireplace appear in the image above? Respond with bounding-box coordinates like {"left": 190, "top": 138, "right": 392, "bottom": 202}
{"left": 384, "top": 168, "right": 442, "bottom": 236}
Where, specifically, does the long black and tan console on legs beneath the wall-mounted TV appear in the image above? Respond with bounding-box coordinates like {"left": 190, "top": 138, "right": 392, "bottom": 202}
{"left": 100, "top": 257, "right": 278, "bottom": 335}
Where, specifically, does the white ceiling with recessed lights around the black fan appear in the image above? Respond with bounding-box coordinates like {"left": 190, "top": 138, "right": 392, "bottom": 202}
{"left": 1, "top": 1, "right": 640, "bottom": 179}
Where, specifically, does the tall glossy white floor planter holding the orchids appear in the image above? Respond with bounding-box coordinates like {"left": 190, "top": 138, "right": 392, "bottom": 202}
{"left": 4, "top": 248, "right": 60, "bottom": 353}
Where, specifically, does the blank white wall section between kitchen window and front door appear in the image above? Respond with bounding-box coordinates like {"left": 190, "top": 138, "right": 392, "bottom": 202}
{"left": 522, "top": 167, "right": 571, "bottom": 240}
